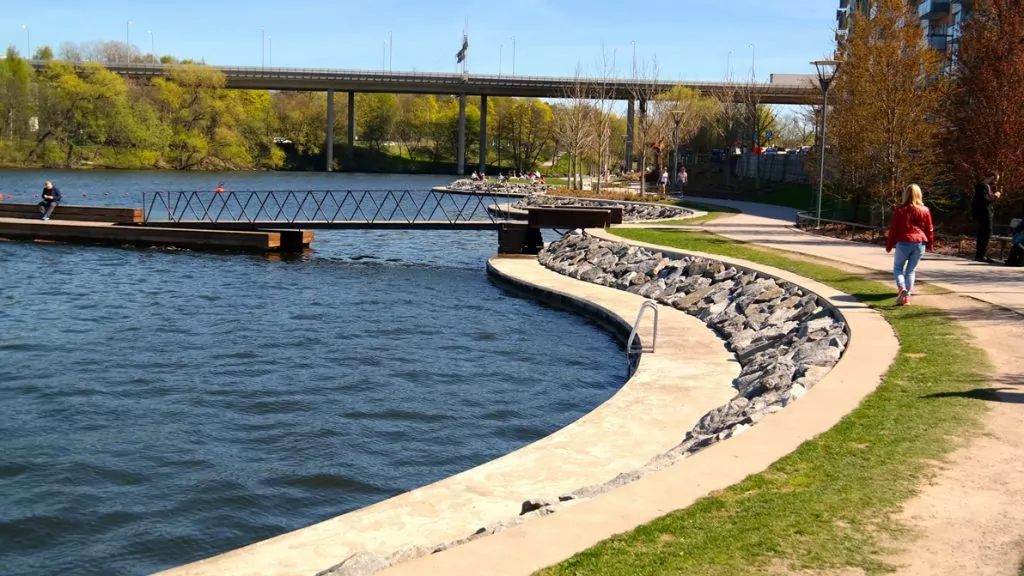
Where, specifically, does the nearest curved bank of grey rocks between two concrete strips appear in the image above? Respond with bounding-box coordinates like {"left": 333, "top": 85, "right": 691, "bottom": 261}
{"left": 539, "top": 232, "right": 849, "bottom": 498}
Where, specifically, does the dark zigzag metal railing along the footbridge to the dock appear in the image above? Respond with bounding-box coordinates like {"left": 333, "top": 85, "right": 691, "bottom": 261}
{"left": 142, "top": 190, "right": 510, "bottom": 225}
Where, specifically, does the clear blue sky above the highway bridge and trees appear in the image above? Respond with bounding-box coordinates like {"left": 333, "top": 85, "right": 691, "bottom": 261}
{"left": 6, "top": 0, "right": 839, "bottom": 81}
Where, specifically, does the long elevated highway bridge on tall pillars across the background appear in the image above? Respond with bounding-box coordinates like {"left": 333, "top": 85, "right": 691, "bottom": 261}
{"left": 31, "top": 60, "right": 820, "bottom": 175}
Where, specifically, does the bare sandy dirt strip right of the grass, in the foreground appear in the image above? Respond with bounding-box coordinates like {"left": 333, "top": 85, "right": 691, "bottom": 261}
{"left": 888, "top": 295, "right": 1024, "bottom": 576}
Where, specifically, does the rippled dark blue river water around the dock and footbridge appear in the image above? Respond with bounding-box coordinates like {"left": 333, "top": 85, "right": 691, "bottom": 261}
{"left": 0, "top": 171, "right": 624, "bottom": 575}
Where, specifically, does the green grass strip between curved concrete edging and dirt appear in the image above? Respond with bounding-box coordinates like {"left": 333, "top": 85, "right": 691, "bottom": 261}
{"left": 540, "top": 229, "right": 988, "bottom": 576}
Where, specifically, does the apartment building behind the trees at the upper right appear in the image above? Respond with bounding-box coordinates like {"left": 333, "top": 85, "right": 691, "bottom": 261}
{"left": 836, "top": 0, "right": 974, "bottom": 64}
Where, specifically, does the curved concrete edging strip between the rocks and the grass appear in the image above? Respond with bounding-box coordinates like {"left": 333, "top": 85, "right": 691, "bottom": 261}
{"left": 380, "top": 235, "right": 899, "bottom": 576}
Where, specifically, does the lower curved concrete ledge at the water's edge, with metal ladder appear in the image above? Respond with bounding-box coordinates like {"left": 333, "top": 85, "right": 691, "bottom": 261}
{"left": 162, "top": 257, "right": 741, "bottom": 576}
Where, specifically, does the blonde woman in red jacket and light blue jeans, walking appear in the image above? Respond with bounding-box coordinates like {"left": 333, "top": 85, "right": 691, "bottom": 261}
{"left": 886, "top": 184, "right": 935, "bottom": 305}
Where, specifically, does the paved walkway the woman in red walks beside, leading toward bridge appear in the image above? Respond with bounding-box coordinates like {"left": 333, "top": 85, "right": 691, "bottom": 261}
{"left": 630, "top": 197, "right": 1024, "bottom": 315}
